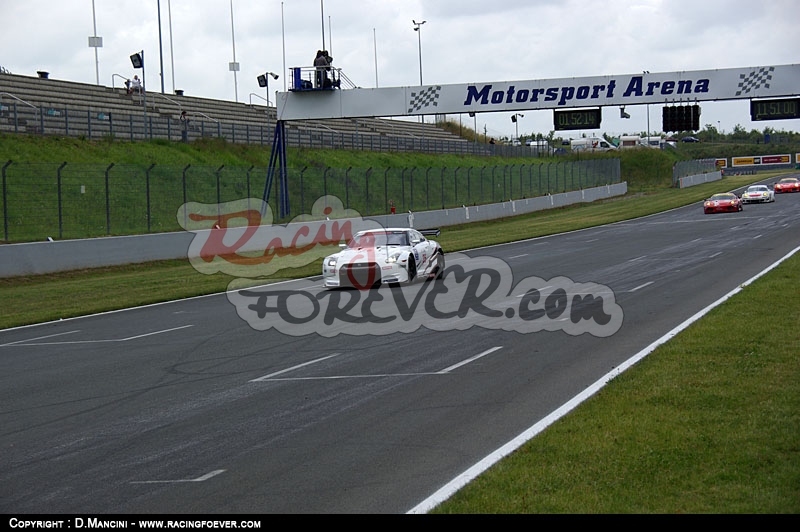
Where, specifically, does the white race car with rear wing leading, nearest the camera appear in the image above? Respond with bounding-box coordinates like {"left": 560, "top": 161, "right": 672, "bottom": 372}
{"left": 322, "top": 228, "right": 444, "bottom": 289}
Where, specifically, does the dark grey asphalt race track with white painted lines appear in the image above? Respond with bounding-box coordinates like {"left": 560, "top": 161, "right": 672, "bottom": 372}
{"left": 0, "top": 180, "right": 800, "bottom": 514}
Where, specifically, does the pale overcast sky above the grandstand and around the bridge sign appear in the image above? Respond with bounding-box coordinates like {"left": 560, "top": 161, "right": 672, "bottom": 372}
{"left": 0, "top": 0, "right": 800, "bottom": 138}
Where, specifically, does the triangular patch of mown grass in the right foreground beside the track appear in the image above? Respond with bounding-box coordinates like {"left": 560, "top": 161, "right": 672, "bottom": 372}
{"left": 434, "top": 254, "right": 800, "bottom": 514}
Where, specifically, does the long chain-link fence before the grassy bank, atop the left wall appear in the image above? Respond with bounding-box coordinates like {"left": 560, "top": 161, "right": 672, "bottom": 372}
{"left": 0, "top": 159, "right": 620, "bottom": 242}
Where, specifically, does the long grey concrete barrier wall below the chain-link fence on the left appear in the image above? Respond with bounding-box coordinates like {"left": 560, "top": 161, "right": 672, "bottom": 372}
{"left": 0, "top": 183, "right": 628, "bottom": 277}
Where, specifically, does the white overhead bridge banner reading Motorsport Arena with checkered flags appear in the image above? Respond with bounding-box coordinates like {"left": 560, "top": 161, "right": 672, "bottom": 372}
{"left": 277, "top": 65, "right": 800, "bottom": 120}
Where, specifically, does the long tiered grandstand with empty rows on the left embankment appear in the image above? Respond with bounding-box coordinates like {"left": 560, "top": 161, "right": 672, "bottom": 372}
{"left": 0, "top": 71, "right": 485, "bottom": 153}
